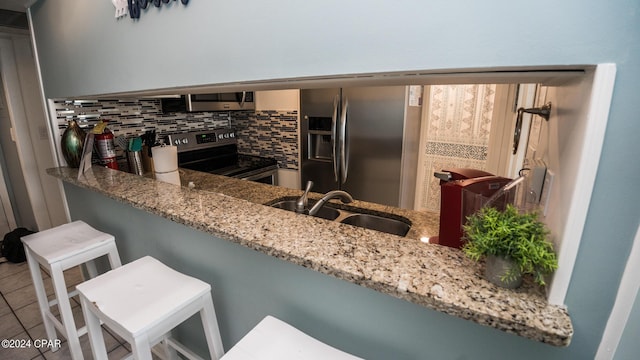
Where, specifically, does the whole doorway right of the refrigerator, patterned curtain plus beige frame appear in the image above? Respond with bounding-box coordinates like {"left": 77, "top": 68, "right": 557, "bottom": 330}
{"left": 414, "top": 84, "right": 536, "bottom": 212}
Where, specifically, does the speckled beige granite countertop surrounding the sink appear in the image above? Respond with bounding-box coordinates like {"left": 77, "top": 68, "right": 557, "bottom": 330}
{"left": 47, "top": 166, "right": 573, "bottom": 346}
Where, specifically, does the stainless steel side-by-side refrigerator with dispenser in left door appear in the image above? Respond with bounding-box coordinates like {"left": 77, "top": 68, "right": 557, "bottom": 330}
{"left": 300, "top": 86, "right": 419, "bottom": 206}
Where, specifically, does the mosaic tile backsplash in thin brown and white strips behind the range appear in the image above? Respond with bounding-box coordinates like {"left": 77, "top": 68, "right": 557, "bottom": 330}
{"left": 54, "top": 99, "right": 299, "bottom": 170}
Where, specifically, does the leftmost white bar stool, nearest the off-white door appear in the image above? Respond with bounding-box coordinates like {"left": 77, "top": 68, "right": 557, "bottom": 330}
{"left": 22, "top": 221, "right": 121, "bottom": 360}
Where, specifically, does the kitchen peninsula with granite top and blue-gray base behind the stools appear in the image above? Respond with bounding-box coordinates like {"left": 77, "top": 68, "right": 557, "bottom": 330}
{"left": 48, "top": 166, "right": 573, "bottom": 359}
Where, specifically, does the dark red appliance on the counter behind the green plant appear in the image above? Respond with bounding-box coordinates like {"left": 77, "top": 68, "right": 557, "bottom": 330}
{"left": 429, "top": 168, "right": 512, "bottom": 248}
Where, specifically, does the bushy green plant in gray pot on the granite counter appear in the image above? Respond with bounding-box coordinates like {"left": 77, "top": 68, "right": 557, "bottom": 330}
{"left": 462, "top": 205, "right": 558, "bottom": 288}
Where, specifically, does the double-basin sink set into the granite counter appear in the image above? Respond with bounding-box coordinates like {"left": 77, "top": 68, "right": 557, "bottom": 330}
{"left": 265, "top": 197, "right": 411, "bottom": 236}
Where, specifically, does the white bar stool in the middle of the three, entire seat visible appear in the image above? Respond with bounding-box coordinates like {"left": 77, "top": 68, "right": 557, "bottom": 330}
{"left": 76, "top": 256, "right": 224, "bottom": 360}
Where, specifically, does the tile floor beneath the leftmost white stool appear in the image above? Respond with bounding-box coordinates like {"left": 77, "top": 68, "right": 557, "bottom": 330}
{"left": 0, "top": 257, "right": 130, "bottom": 360}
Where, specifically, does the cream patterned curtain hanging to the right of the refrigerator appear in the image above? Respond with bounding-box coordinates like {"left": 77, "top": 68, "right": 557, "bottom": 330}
{"left": 417, "top": 84, "right": 496, "bottom": 211}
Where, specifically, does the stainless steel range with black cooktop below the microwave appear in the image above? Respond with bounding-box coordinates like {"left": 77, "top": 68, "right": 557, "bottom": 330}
{"left": 165, "top": 129, "right": 278, "bottom": 185}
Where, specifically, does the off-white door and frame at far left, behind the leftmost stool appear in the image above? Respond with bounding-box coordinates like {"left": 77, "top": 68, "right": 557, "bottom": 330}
{"left": 0, "top": 31, "right": 67, "bottom": 230}
